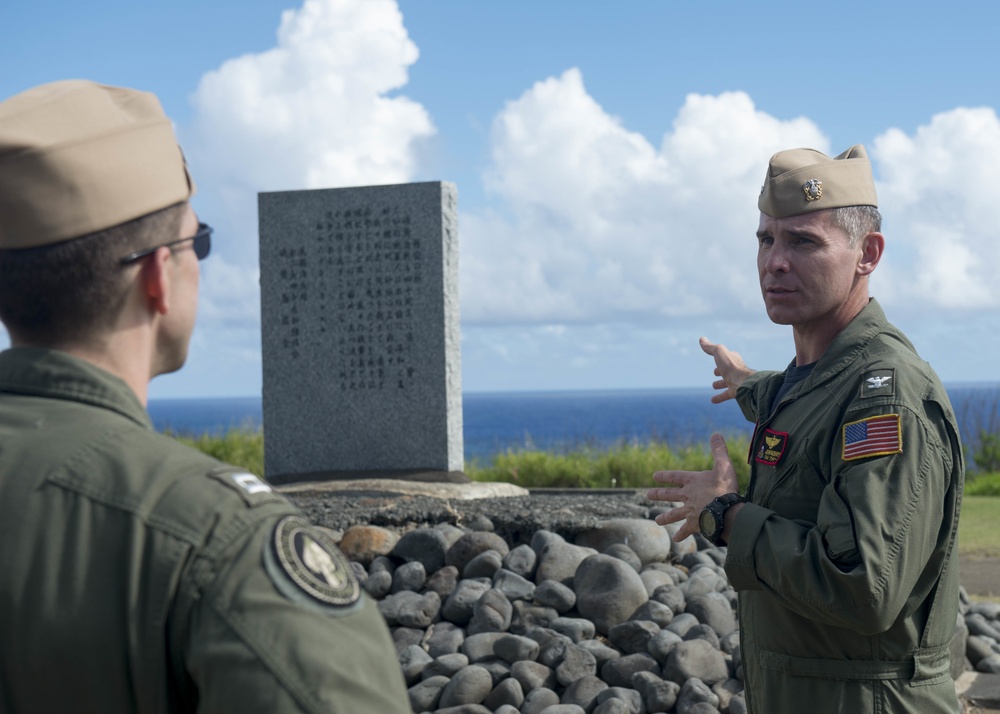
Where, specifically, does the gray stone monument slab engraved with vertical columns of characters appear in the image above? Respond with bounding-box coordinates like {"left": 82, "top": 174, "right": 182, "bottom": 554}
{"left": 258, "top": 182, "right": 464, "bottom": 482}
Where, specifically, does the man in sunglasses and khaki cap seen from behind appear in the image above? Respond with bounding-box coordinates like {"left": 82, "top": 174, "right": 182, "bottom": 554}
{"left": 0, "top": 80, "right": 410, "bottom": 714}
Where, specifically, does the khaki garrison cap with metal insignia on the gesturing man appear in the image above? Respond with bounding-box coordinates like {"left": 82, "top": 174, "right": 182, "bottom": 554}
{"left": 757, "top": 144, "right": 878, "bottom": 218}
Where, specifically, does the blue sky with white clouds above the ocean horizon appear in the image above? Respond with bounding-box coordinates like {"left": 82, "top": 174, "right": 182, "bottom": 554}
{"left": 0, "top": 0, "right": 1000, "bottom": 398}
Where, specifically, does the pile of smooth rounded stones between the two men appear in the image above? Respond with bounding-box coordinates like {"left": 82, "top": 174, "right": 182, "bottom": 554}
{"left": 332, "top": 516, "right": 746, "bottom": 714}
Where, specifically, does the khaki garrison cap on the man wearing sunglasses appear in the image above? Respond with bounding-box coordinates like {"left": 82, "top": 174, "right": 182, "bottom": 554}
{"left": 0, "top": 80, "right": 194, "bottom": 249}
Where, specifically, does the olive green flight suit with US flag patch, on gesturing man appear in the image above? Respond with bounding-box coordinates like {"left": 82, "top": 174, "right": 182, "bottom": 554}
{"left": 725, "top": 300, "right": 964, "bottom": 714}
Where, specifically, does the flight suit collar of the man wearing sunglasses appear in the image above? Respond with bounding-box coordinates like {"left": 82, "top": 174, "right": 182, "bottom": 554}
{"left": 0, "top": 347, "right": 153, "bottom": 429}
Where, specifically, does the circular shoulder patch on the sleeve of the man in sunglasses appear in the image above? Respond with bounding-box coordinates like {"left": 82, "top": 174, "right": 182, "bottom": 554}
{"left": 265, "top": 516, "right": 361, "bottom": 607}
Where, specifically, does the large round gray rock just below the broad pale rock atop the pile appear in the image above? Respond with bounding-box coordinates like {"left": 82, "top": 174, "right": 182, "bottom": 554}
{"left": 574, "top": 555, "right": 649, "bottom": 635}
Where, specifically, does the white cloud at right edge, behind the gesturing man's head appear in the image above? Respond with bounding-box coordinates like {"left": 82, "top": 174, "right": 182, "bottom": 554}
{"left": 872, "top": 108, "right": 1000, "bottom": 310}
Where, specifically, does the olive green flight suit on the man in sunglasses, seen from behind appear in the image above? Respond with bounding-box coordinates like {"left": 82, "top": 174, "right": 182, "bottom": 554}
{"left": 0, "top": 348, "right": 410, "bottom": 714}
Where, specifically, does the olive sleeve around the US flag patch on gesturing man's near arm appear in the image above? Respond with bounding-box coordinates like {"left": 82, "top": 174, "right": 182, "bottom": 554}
{"left": 725, "top": 405, "right": 961, "bottom": 634}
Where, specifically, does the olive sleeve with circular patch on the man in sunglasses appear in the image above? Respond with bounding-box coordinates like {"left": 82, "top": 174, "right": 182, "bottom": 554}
{"left": 178, "top": 500, "right": 410, "bottom": 714}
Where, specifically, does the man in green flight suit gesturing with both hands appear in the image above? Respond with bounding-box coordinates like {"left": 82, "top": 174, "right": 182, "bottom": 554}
{"left": 649, "top": 146, "right": 964, "bottom": 714}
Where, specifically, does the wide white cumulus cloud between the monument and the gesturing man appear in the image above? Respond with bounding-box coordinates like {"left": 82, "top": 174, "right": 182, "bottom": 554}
{"left": 462, "top": 69, "right": 828, "bottom": 324}
